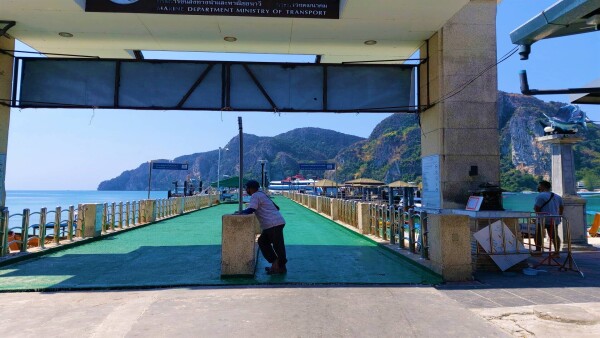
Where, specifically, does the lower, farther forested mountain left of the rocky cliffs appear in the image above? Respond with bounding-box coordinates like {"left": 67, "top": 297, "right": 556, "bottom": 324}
{"left": 98, "top": 128, "right": 363, "bottom": 190}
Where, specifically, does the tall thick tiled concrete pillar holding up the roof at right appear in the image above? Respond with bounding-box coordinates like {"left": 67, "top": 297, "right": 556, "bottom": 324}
{"left": 419, "top": 0, "right": 500, "bottom": 209}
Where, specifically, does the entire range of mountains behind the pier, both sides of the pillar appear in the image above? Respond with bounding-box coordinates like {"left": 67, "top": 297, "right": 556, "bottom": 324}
{"left": 98, "top": 92, "right": 600, "bottom": 191}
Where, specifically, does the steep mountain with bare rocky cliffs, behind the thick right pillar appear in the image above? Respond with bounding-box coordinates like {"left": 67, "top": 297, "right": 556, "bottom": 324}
{"left": 328, "top": 92, "right": 600, "bottom": 191}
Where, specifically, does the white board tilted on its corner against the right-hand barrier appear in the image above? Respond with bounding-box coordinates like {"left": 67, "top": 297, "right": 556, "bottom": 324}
{"left": 473, "top": 221, "right": 529, "bottom": 271}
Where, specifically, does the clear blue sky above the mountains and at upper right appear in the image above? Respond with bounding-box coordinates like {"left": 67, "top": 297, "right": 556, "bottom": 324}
{"left": 6, "top": 0, "right": 600, "bottom": 190}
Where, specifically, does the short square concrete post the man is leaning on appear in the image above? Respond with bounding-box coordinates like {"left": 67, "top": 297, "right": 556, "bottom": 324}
{"left": 221, "top": 215, "right": 260, "bottom": 277}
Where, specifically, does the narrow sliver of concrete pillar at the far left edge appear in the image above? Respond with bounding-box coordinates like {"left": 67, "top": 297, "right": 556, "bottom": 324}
{"left": 0, "top": 36, "right": 15, "bottom": 208}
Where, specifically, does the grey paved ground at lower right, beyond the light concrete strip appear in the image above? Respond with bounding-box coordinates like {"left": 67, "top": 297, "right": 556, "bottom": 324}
{"left": 437, "top": 238, "right": 600, "bottom": 337}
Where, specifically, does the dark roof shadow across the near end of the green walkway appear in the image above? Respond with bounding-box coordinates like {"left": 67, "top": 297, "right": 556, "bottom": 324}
{"left": 0, "top": 245, "right": 439, "bottom": 291}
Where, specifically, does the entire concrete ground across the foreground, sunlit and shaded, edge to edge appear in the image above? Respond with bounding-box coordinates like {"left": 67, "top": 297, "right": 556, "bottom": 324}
{"left": 0, "top": 199, "right": 600, "bottom": 338}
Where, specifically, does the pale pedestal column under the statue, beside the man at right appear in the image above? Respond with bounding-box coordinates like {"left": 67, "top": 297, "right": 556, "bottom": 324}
{"left": 537, "top": 135, "right": 588, "bottom": 245}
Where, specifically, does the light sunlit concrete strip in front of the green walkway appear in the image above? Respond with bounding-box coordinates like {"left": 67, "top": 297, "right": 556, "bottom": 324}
{"left": 0, "top": 287, "right": 508, "bottom": 338}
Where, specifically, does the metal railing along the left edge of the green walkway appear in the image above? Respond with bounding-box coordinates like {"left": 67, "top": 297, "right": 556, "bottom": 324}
{"left": 0, "top": 195, "right": 213, "bottom": 257}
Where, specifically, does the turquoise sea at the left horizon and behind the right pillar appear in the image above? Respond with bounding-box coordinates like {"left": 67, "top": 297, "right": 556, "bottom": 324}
{"left": 6, "top": 190, "right": 600, "bottom": 224}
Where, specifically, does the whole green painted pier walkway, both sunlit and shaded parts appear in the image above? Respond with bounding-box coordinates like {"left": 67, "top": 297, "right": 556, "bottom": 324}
{"left": 0, "top": 197, "right": 441, "bottom": 291}
